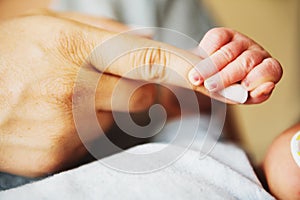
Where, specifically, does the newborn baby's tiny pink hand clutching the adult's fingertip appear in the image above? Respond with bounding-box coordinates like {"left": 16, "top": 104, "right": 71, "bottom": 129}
{"left": 189, "top": 28, "right": 282, "bottom": 104}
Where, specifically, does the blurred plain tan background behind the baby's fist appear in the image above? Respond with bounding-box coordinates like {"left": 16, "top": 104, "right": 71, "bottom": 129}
{"left": 203, "top": 0, "right": 300, "bottom": 163}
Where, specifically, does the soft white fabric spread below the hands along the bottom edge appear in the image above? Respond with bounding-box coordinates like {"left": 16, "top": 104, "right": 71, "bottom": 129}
{"left": 0, "top": 143, "right": 273, "bottom": 200}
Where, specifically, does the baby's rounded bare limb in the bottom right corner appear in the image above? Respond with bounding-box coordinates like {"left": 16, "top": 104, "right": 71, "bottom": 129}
{"left": 263, "top": 123, "right": 300, "bottom": 200}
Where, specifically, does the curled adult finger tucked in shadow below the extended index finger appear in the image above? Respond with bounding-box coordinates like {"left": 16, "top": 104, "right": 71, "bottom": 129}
{"left": 95, "top": 74, "right": 157, "bottom": 112}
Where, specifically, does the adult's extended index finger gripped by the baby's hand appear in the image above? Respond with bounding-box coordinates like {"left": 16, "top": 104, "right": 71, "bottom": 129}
{"left": 68, "top": 24, "right": 241, "bottom": 102}
